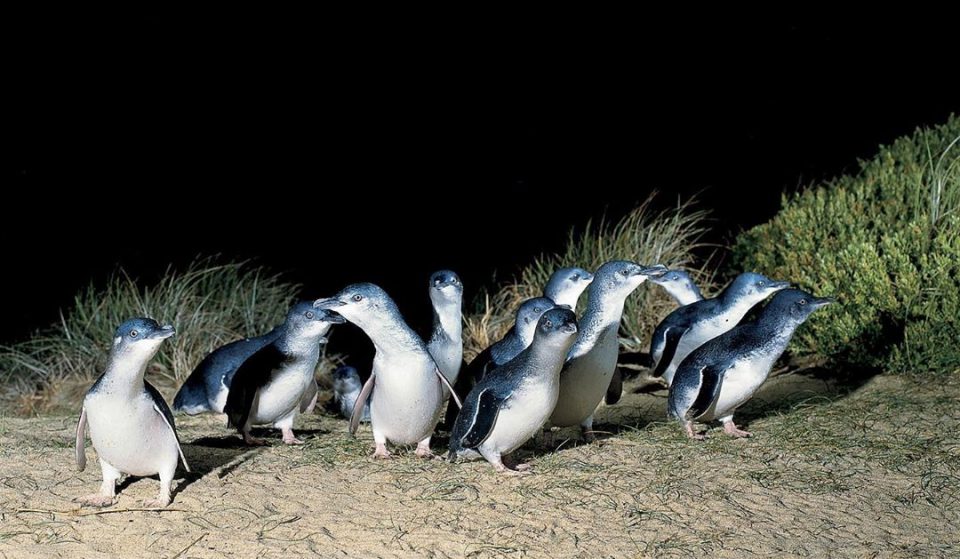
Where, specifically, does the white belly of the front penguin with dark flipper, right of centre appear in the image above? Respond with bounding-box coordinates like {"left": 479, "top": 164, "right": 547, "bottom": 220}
{"left": 480, "top": 382, "right": 560, "bottom": 454}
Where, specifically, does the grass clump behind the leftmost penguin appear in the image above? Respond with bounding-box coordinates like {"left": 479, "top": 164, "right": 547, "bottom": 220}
{"left": 0, "top": 259, "right": 316, "bottom": 414}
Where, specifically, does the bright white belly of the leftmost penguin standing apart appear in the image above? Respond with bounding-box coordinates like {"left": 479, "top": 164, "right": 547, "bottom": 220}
{"left": 84, "top": 394, "right": 180, "bottom": 476}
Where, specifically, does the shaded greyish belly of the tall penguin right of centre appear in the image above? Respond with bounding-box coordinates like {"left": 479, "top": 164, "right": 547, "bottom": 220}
{"left": 550, "top": 336, "right": 619, "bottom": 427}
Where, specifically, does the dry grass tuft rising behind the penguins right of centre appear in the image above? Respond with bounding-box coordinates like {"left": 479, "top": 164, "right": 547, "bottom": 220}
{"left": 464, "top": 196, "right": 712, "bottom": 361}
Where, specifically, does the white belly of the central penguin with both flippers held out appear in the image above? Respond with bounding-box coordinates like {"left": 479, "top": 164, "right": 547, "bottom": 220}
{"left": 370, "top": 358, "right": 443, "bottom": 444}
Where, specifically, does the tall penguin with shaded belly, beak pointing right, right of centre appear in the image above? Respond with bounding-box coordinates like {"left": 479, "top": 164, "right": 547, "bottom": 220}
{"left": 549, "top": 260, "right": 665, "bottom": 441}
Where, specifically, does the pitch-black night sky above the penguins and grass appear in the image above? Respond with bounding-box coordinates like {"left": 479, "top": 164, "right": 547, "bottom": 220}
{"left": 9, "top": 20, "right": 960, "bottom": 340}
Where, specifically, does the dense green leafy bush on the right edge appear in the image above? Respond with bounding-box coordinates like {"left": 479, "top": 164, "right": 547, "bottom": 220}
{"left": 733, "top": 116, "right": 960, "bottom": 371}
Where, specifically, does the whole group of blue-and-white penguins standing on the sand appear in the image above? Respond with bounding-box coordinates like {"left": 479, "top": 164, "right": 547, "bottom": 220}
{"left": 76, "top": 260, "right": 833, "bottom": 507}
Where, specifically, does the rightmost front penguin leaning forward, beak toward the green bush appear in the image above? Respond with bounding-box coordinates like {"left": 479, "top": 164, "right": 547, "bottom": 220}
{"left": 667, "top": 289, "right": 834, "bottom": 439}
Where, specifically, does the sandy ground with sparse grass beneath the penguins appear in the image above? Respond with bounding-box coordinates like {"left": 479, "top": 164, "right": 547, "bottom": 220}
{"left": 0, "top": 375, "right": 960, "bottom": 558}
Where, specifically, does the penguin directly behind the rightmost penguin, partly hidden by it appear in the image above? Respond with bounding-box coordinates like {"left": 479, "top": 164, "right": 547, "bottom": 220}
{"left": 650, "top": 272, "right": 790, "bottom": 386}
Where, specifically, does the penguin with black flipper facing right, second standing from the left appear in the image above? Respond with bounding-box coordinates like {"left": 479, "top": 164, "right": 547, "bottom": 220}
{"left": 223, "top": 302, "right": 346, "bottom": 445}
